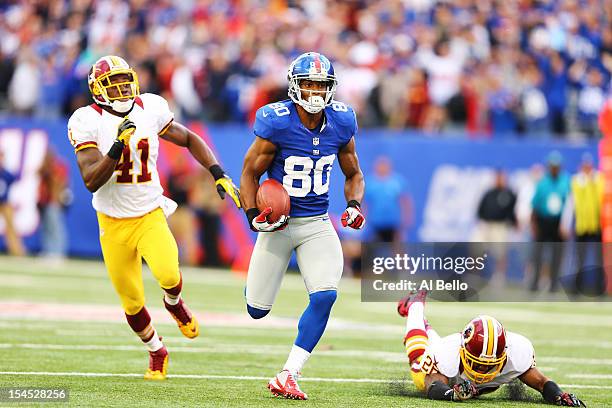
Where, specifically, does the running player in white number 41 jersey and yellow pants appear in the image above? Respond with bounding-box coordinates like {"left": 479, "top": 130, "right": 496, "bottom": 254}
{"left": 68, "top": 55, "right": 240, "bottom": 380}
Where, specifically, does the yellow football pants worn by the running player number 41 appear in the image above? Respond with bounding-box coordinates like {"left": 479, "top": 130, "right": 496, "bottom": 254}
{"left": 98, "top": 208, "right": 180, "bottom": 315}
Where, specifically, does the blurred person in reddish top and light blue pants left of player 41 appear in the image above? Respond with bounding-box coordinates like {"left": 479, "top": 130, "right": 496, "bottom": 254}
{"left": 38, "top": 149, "right": 72, "bottom": 262}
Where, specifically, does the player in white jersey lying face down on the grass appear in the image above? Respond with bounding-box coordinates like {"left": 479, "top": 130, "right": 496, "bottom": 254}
{"left": 397, "top": 291, "right": 586, "bottom": 407}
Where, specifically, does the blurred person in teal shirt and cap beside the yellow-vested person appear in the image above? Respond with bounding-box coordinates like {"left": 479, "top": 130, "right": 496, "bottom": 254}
{"left": 530, "top": 151, "right": 570, "bottom": 292}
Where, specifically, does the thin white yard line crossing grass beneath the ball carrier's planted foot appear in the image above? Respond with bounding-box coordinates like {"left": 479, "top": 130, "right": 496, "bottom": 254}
{"left": 0, "top": 371, "right": 612, "bottom": 390}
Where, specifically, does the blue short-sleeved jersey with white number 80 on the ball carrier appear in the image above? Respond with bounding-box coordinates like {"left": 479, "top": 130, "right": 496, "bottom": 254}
{"left": 253, "top": 99, "right": 357, "bottom": 217}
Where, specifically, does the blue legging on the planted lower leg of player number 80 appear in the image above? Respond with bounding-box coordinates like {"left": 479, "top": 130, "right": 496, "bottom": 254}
{"left": 295, "top": 290, "right": 338, "bottom": 352}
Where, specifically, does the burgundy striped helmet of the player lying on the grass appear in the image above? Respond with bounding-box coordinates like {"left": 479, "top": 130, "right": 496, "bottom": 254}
{"left": 459, "top": 316, "right": 508, "bottom": 384}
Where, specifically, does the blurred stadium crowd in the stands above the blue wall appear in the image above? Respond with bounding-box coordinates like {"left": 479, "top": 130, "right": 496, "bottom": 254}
{"left": 0, "top": 0, "right": 612, "bottom": 137}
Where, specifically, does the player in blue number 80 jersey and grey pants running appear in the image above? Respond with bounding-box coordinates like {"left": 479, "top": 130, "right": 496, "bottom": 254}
{"left": 240, "top": 52, "right": 365, "bottom": 399}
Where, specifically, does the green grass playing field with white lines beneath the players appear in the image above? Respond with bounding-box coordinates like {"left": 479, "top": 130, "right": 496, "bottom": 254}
{"left": 0, "top": 257, "right": 612, "bottom": 408}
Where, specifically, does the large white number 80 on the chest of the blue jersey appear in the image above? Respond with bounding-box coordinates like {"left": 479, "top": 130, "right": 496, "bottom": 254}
{"left": 283, "top": 154, "right": 336, "bottom": 197}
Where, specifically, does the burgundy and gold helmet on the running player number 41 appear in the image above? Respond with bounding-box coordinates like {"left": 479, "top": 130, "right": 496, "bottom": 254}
{"left": 88, "top": 55, "right": 140, "bottom": 113}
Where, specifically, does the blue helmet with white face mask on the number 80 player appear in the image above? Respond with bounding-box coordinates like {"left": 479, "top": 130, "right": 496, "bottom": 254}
{"left": 287, "top": 52, "right": 338, "bottom": 113}
